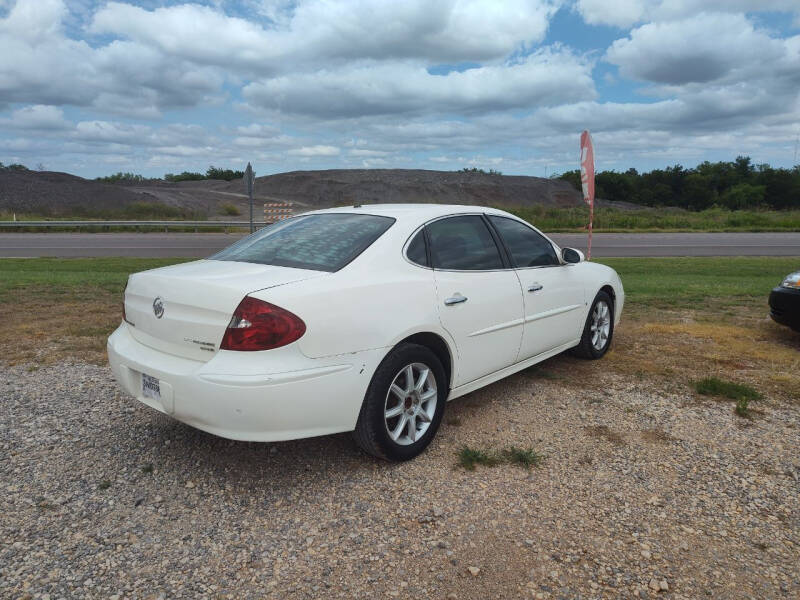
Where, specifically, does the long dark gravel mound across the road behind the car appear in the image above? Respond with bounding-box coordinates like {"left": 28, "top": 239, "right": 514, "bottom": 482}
{"left": 0, "top": 169, "right": 616, "bottom": 219}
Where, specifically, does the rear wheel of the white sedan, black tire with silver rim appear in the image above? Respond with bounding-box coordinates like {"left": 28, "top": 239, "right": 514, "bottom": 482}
{"left": 353, "top": 344, "right": 448, "bottom": 461}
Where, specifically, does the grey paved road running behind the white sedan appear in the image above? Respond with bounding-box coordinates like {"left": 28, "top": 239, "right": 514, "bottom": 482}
{"left": 0, "top": 233, "right": 800, "bottom": 258}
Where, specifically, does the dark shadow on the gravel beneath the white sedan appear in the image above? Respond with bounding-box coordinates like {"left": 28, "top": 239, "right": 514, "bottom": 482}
{"left": 103, "top": 357, "right": 575, "bottom": 495}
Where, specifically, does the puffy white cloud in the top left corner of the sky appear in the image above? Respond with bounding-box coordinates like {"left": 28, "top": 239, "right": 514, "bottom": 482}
{"left": 0, "top": 0, "right": 222, "bottom": 117}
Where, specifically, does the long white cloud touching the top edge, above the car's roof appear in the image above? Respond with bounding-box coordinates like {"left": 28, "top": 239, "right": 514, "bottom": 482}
{"left": 90, "top": 0, "right": 561, "bottom": 74}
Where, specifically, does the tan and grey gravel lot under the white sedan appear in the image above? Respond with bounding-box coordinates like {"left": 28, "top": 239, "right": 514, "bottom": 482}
{"left": 0, "top": 357, "right": 800, "bottom": 600}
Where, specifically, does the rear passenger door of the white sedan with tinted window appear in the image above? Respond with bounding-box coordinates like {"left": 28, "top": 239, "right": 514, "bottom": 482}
{"left": 425, "top": 215, "right": 523, "bottom": 386}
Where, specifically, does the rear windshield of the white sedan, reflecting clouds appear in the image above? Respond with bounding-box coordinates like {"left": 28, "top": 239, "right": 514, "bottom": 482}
{"left": 209, "top": 213, "right": 394, "bottom": 271}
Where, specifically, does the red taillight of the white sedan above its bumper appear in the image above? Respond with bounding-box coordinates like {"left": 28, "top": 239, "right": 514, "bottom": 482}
{"left": 219, "top": 296, "right": 306, "bottom": 351}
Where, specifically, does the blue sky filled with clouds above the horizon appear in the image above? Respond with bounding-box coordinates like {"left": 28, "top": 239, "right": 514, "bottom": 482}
{"left": 0, "top": 0, "right": 800, "bottom": 177}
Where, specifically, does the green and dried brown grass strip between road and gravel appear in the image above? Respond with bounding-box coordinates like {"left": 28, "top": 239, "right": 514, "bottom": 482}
{"left": 0, "top": 258, "right": 800, "bottom": 405}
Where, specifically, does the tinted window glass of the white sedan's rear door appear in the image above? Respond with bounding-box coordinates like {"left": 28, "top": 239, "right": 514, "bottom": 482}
{"left": 427, "top": 215, "right": 503, "bottom": 271}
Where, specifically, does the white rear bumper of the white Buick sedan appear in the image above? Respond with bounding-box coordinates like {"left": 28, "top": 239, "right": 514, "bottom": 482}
{"left": 107, "top": 323, "right": 385, "bottom": 442}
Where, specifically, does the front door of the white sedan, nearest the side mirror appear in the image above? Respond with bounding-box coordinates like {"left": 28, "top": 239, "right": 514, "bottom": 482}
{"left": 489, "top": 215, "right": 586, "bottom": 360}
